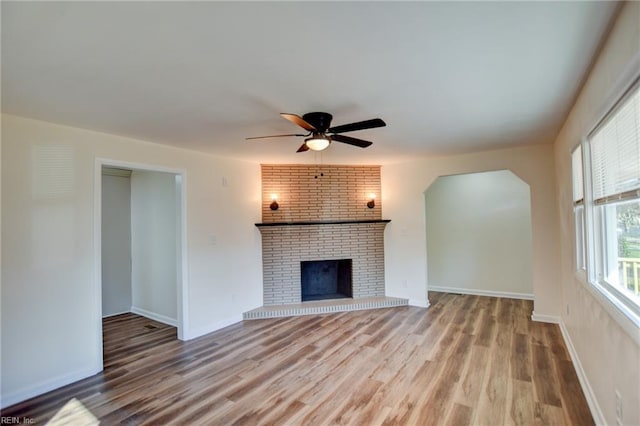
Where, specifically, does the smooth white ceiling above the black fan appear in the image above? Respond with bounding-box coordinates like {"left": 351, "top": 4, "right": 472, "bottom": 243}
{"left": 1, "top": 1, "right": 619, "bottom": 164}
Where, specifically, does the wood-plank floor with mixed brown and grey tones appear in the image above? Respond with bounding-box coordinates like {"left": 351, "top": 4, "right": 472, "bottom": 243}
{"left": 2, "top": 293, "right": 593, "bottom": 426}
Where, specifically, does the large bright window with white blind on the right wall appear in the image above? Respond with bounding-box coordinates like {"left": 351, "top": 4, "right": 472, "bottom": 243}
{"left": 588, "top": 82, "right": 640, "bottom": 314}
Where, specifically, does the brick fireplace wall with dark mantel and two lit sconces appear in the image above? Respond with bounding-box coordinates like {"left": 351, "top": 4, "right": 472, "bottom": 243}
{"left": 256, "top": 165, "right": 389, "bottom": 307}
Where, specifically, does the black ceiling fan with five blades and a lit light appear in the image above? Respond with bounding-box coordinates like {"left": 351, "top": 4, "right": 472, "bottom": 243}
{"left": 247, "top": 112, "right": 387, "bottom": 152}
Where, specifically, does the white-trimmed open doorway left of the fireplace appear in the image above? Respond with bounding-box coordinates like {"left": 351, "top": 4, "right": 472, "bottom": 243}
{"left": 94, "top": 159, "right": 187, "bottom": 372}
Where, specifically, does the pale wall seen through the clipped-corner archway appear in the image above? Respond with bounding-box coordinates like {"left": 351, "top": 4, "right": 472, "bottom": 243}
{"left": 425, "top": 170, "right": 533, "bottom": 298}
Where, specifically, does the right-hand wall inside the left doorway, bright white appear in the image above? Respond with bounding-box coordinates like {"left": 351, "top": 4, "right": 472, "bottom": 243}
{"left": 131, "top": 170, "right": 178, "bottom": 325}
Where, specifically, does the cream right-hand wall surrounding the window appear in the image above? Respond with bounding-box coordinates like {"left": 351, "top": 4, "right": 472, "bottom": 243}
{"left": 555, "top": 2, "right": 640, "bottom": 425}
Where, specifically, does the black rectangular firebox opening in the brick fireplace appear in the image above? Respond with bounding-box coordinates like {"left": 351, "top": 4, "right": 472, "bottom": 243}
{"left": 300, "top": 259, "right": 353, "bottom": 302}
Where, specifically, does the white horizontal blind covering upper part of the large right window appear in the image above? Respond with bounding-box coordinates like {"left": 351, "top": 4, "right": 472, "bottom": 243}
{"left": 589, "top": 84, "right": 640, "bottom": 204}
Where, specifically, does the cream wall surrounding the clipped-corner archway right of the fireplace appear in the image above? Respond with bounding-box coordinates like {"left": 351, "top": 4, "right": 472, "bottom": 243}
{"left": 382, "top": 145, "right": 560, "bottom": 312}
